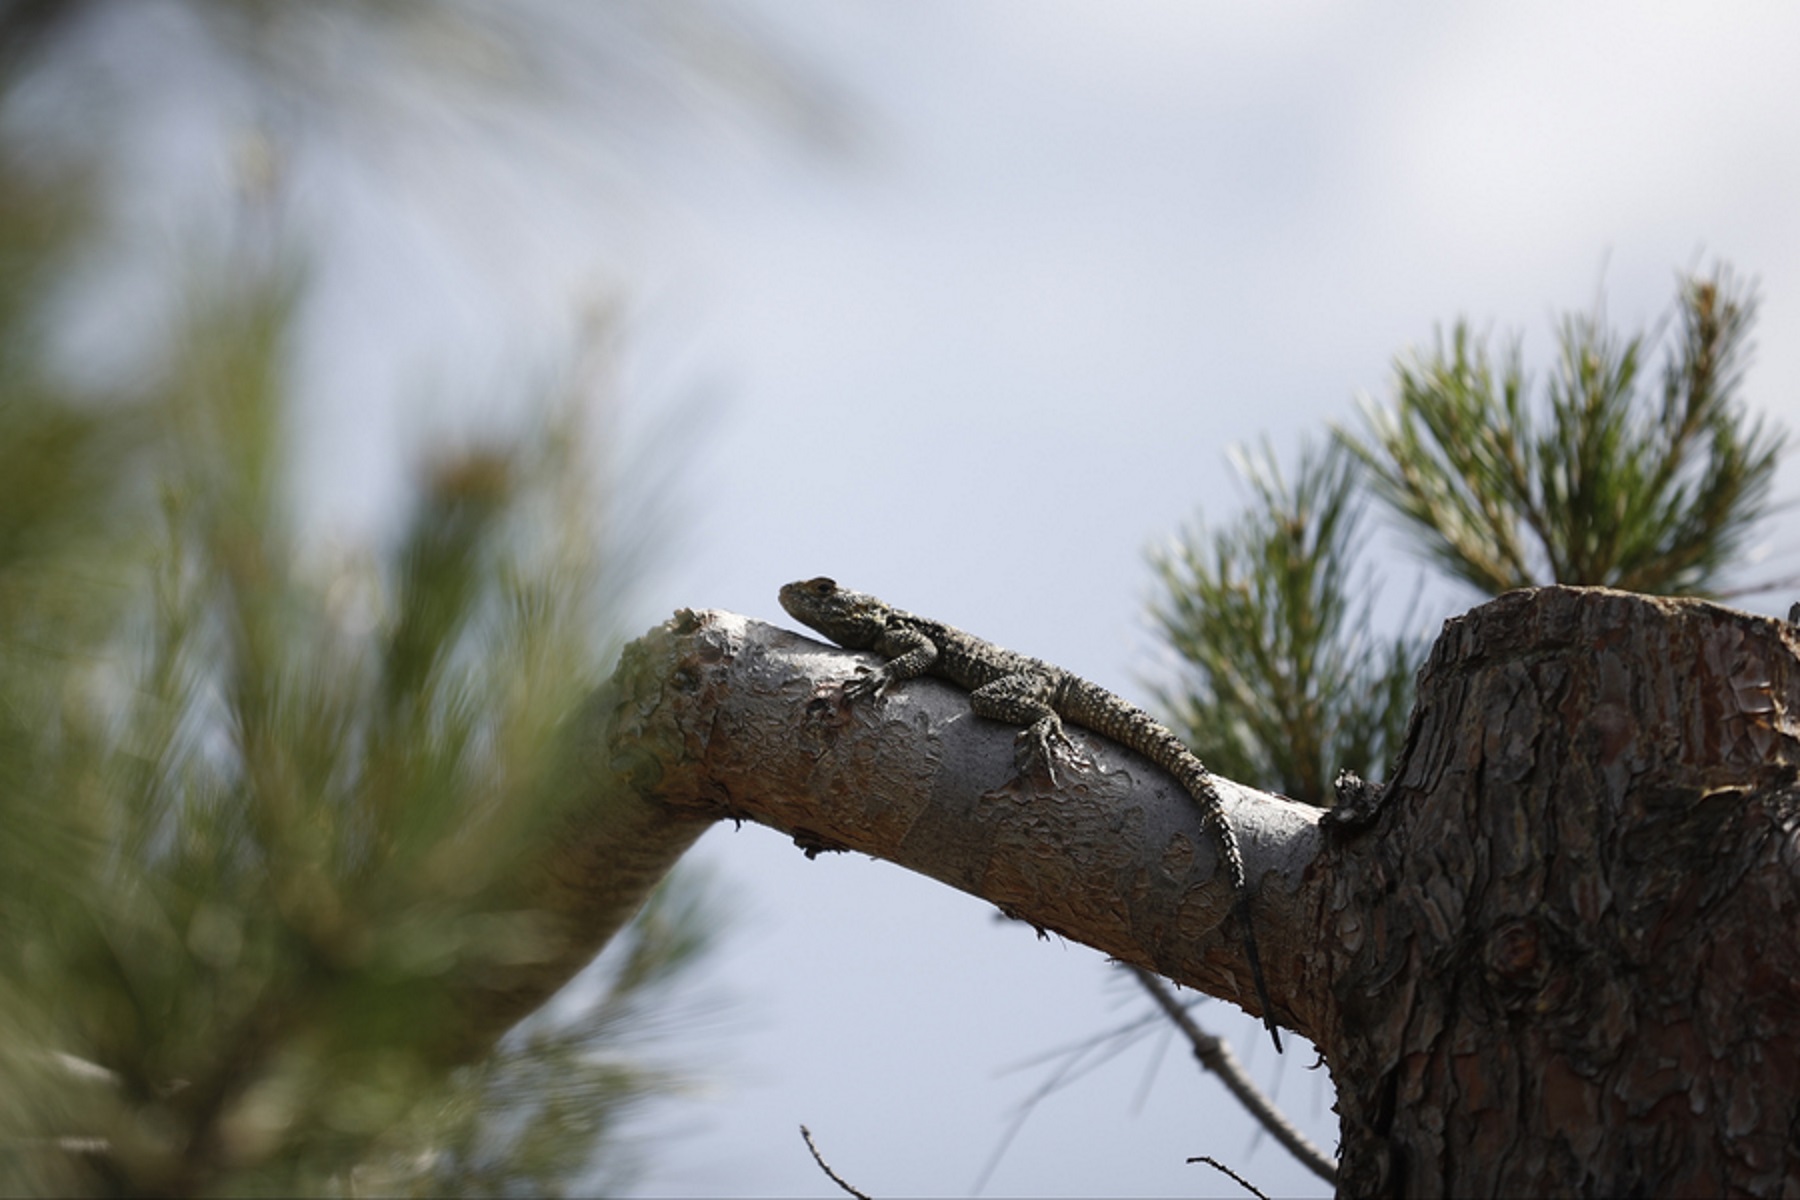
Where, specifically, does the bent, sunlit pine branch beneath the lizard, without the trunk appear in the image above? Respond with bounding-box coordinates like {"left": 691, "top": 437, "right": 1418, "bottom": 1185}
{"left": 448, "top": 610, "right": 1323, "bottom": 1047}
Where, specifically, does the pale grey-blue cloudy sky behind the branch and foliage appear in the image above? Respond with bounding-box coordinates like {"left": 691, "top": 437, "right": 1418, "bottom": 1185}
{"left": 28, "top": 0, "right": 1800, "bottom": 1196}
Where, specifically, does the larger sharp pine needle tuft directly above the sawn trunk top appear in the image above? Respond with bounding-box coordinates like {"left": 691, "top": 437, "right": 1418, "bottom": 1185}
{"left": 1345, "top": 270, "right": 1784, "bottom": 596}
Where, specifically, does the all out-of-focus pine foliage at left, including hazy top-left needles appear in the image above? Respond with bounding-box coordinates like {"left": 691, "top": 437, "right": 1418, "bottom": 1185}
{"left": 0, "top": 0, "right": 855, "bottom": 1195}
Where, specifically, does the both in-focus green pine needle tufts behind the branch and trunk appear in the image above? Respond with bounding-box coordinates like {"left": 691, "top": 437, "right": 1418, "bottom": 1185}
{"left": 1152, "top": 268, "right": 1786, "bottom": 804}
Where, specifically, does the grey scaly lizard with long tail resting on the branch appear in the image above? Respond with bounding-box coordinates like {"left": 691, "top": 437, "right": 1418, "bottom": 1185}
{"left": 781, "top": 576, "right": 1282, "bottom": 1052}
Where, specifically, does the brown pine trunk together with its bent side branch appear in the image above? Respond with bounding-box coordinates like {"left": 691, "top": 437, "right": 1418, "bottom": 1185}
{"left": 482, "top": 588, "right": 1800, "bottom": 1196}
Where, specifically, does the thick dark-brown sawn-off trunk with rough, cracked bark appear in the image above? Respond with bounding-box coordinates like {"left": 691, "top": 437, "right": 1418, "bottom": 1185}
{"left": 1318, "top": 588, "right": 1800, "bottom": 1196}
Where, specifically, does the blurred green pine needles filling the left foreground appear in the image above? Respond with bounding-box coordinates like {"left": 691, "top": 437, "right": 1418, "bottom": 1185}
{"left": 0, "top": 173, "right": 715, "bottom": 1195}
